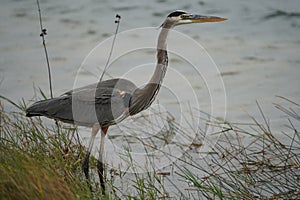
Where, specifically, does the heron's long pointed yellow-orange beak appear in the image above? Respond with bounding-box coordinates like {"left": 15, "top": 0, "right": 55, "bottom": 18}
{"left": 179, "top": 14, "right": 227, "bottom": 24}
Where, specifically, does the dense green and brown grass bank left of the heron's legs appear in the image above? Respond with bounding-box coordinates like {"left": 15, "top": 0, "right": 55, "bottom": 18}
{"left": 0, "top": 101, "right": 98, "bottom": 199}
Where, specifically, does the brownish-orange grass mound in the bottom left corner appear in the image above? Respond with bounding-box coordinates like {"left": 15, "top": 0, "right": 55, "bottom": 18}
{"left": 0, "top": 145, "right": 75, "bottom": 199}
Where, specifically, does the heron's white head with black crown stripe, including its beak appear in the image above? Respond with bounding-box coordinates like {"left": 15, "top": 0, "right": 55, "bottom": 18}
{"left": 162, "top": 10, "right": 227, "bottom": 27}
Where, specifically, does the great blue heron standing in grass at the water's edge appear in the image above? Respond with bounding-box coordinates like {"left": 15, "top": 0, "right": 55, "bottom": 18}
{"left": 26, "top": 10, "right": 226, "bottom": 191}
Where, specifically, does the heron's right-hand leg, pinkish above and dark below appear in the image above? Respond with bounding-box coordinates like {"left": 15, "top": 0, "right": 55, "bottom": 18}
{"left": 97, "top": 127, "right": 108, "bottom": 193}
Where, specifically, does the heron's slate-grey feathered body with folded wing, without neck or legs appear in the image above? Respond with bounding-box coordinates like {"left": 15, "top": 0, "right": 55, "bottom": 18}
{"left": 27, "top": 79, "right": 137, "bottom": 127}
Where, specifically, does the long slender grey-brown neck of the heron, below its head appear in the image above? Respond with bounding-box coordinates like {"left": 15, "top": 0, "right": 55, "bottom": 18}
{"left": 129, "top": 23, "right": 171, "bottom": 115}
